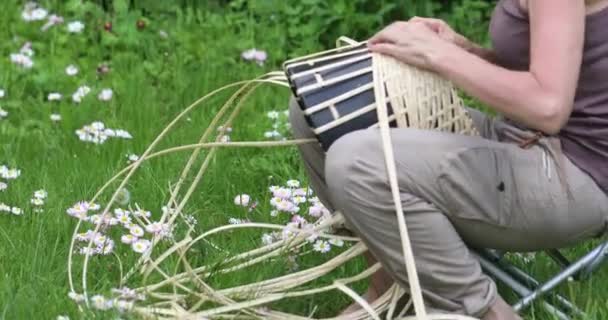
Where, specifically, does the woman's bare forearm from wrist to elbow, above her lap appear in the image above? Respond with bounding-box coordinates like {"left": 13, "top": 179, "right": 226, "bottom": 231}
{"left": 431, "top": 48, "right": 567, "bottom": 134}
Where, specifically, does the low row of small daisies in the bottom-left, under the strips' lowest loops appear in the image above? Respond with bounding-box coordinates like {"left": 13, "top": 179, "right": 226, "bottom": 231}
{"left": 68, "top": 287, "right": 146, "bottom": 312}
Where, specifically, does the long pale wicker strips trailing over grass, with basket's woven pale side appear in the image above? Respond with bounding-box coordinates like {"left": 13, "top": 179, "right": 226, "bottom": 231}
{"left": 68, "top": 39, "right": 477, "bottom": 320}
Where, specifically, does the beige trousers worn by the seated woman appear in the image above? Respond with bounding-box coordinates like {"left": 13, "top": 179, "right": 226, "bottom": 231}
{"left": 290, "top": 100, "right": 608, "bottom": 317}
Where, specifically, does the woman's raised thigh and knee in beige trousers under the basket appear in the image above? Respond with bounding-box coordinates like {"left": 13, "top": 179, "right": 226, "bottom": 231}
{"left": 329, "top": 129, "right": 606, "bottom": 250}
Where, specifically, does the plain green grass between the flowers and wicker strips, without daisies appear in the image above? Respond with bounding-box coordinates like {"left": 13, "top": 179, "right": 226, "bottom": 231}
{"left": 0, "top": 1, "right": 608, "bottom": 320}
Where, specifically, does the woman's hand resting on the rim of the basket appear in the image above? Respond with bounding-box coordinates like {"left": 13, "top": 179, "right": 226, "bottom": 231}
{"left": 368, "top": 21, "right": 459, "bottom": 70}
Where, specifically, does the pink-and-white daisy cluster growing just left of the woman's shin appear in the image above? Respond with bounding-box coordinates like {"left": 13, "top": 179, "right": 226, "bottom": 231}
{"left": 233, "top": 180, "right": 344, "bottom": 253}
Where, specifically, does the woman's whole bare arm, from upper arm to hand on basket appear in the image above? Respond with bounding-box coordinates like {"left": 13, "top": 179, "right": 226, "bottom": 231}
{"left": 370, "top": 0, "right": 585, "bottom": 134}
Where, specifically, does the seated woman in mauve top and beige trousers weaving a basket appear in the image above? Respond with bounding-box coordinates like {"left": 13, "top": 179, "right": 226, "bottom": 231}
{"left": 291, "top": 0, "right": 608, "bottom": 319}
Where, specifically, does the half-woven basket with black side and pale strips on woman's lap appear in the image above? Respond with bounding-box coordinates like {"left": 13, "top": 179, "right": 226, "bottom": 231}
{"left": 285, "top": 44, "right": 476, "bottom": 150}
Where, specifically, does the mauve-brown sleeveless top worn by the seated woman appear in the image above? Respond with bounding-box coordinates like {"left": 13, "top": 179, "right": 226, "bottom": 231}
{"left": 490, "top": 0, "right": 608, "bottom": 193}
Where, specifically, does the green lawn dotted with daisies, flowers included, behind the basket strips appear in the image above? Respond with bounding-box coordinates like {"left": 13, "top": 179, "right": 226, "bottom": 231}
{"left": 0, "top": 0, "right": 608, "bottom": 320}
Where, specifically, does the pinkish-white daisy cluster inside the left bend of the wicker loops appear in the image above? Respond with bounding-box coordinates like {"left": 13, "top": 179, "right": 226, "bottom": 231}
{"left": 66, "top": 201, "right": 173, "bottom": 255}
